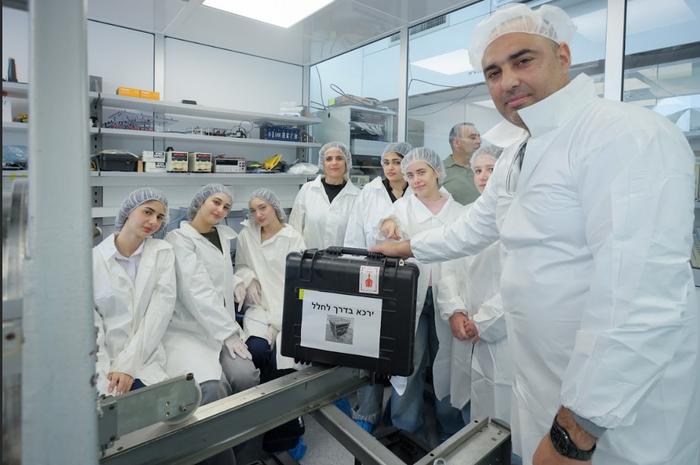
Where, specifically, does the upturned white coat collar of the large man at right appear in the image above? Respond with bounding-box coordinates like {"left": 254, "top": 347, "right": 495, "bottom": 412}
{"left": 518, "top": 73, "right": 596, "bottom": 137}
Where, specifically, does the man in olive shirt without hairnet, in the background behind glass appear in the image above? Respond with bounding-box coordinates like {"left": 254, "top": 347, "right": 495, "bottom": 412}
{"left": 442, "top": 123, "right": 481, "bottom": 205}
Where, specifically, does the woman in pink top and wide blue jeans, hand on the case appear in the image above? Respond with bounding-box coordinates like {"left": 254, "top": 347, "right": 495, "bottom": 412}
{"left": 380, "top": 147, "right": 468, "bottom": 440}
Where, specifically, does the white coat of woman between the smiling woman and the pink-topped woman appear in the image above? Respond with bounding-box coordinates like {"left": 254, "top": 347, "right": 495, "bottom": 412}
{"left": 345, "top": 176, "right": 411, "bottom": 249}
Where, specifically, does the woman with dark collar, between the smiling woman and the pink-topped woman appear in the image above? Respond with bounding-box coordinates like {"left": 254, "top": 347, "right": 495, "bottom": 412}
{"left": 345, "top": 142, "right": 412, "bottom": 432}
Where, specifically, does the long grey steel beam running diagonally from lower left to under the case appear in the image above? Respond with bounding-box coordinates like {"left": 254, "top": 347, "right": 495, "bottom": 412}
{"left": 100, "top": 367, "right": 367, "bottom": 465}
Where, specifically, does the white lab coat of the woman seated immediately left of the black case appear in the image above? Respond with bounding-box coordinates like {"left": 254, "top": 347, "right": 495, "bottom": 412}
{"left": 234, "top": 220, "right": 306, "bottom": 370}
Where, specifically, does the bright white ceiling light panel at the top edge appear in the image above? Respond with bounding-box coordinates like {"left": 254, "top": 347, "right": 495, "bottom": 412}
{"left": 202, "top": 0, "right": 333, "bottom": 27}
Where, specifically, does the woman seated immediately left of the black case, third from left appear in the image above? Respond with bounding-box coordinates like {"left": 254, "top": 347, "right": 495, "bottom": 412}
{"left": 234, "top": 188, "right": 306, "bottom": 376}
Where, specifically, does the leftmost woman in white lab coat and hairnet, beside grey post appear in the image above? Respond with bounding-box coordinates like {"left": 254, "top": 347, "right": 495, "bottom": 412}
{"left": 92, "top": 188, "right": 176, "bottom": 395}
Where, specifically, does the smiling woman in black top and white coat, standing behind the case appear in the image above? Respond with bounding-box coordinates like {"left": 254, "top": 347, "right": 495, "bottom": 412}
{"left": 289, "top": 142, "right": 360, "bottom": 249}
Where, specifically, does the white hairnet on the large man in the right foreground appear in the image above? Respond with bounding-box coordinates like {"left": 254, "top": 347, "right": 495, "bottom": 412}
{"left": 469, "top": 3, "right": 576, "bottom": 70}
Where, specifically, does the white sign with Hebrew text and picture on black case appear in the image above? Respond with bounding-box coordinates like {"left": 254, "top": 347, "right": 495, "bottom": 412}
{"left": 299, "top": 289, "right": 382, "bottom": 358}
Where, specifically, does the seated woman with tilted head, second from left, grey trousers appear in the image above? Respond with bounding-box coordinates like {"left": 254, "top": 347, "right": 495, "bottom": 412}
{"left": 163, "top": 184, "right": 259, "bottom": 403}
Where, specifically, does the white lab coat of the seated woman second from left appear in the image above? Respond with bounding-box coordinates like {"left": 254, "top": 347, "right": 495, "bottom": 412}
{"left": 163, "top": 221, "right": 242, "bottom": 383}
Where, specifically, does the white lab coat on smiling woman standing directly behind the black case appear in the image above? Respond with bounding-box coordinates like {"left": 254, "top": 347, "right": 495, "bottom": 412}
{"left": 289, "top": 175, "right": 360, "bottom": 249}
